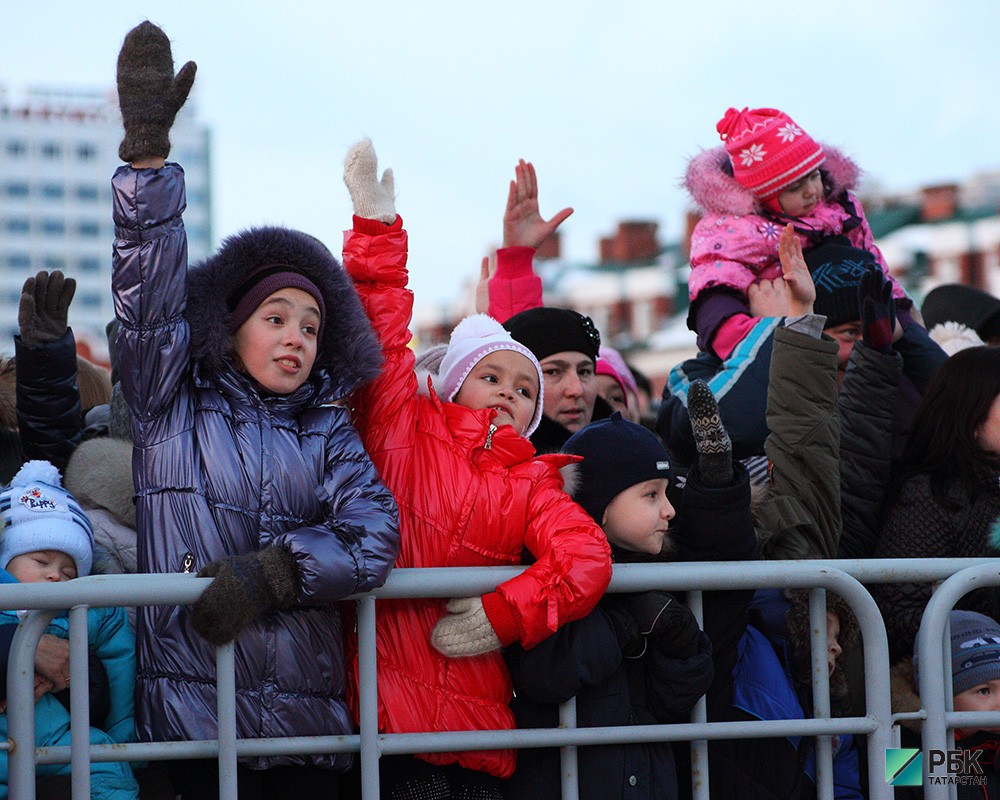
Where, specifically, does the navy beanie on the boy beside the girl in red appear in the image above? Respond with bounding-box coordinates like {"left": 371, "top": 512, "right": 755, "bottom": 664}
{"left": 562, "top": 411, "right": 673, "bottom": 525}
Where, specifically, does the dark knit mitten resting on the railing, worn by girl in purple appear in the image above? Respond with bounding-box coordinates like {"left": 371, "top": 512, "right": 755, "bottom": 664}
{"left": 191, "top": 547, "right": 301, "bottom": 645}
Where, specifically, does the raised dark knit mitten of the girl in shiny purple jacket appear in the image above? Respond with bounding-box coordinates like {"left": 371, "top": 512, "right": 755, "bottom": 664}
{"left": 118, "top": 21, "right": 197, "bottom": 162}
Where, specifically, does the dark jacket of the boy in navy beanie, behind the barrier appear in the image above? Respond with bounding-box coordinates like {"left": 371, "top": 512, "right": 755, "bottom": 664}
{"left": 504, "top": 594, "right": 712, "bottom": 800}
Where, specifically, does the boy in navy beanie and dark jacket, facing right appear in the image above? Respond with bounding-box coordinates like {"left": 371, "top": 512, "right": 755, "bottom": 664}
{"left": 504, "top": 412, "right": 714, "bottom": 800}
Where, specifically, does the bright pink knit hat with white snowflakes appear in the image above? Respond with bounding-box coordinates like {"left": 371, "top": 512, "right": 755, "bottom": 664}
{"left": 715, "top": 108, "right": 826, "bottom": 200}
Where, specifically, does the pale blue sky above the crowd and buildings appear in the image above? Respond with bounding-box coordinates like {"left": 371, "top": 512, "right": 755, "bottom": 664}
{"left": 0, "top": 0, "right": 1000, "bottom": 303}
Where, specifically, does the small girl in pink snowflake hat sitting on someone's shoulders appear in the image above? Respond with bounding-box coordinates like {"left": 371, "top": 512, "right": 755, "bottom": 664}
{"left": 684, "top": 108, "right": 912, "bottom": 358}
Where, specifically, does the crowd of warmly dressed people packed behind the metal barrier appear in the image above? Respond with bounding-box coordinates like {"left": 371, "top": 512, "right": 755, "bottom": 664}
{"left": 0, "top": 17, "right": 1000, "bottom": 800}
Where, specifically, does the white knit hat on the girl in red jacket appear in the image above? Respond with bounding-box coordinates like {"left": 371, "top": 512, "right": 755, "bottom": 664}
{"left": 438, "top": 314, "right": 545, "bottom": 436}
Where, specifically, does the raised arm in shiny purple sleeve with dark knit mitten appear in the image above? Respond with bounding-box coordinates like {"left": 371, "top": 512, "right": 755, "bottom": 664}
{"left": 112, "top": 22, "right": 195, "bottom": 422}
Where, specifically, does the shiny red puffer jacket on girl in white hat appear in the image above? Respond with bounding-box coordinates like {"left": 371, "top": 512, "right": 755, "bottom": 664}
{"left": 344, "top": 217, "right": 611, "bottom": 777}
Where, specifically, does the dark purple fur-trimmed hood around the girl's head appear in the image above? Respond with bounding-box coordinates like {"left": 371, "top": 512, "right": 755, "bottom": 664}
{"left": 185, "top": 227, "right": 382, "bottom": 394}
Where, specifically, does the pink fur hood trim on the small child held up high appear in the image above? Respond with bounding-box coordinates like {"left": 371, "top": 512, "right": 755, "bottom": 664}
{"left": 683, "top": 144, "right": 861, "bottom": 216}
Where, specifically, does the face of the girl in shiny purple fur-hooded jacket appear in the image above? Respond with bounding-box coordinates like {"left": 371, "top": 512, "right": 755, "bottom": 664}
{"left": 235, "top": 288, "right": 320, "bottom": 394}
